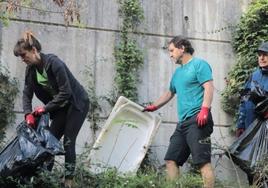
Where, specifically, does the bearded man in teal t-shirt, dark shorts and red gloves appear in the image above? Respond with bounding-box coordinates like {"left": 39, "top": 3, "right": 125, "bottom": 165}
{"left": 144, "top": 36, "right": 215, "bottom": 188}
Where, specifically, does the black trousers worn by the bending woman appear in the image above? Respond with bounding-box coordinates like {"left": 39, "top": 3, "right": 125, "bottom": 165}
{"left": 49, "top": 100, "right": 89, "bottom": 178}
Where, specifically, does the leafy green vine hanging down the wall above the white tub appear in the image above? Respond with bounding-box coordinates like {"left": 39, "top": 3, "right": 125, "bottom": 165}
{"left": 114, "top": 0, "right": 144, "bottom": 101}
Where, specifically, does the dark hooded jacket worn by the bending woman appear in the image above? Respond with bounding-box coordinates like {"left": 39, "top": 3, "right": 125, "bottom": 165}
{"left": 23, "top": 53, "right": 88, "bottom": 114}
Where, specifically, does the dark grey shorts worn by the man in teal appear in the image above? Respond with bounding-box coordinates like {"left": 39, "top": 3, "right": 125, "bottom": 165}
{"left": 165, "top": 113, "right": 214, "bottom": 166}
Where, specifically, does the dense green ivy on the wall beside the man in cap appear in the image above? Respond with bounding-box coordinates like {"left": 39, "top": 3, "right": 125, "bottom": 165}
{"left": 221, "top": 0, "right": 268, "bottom": 119}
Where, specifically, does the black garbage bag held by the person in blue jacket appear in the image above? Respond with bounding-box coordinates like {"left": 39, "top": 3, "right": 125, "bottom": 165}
{"left": 228, "top": 81, "right": 268, "bottom": 188}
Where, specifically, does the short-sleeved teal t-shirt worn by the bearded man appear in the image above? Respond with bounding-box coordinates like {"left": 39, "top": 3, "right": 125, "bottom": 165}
{"left": 169, "top": 58, "right": 212, "bottom": 122}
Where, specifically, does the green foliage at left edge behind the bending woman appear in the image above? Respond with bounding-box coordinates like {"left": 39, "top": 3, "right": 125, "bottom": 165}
{"left": 0, "top": 64, "right": 18, "bottom": 141}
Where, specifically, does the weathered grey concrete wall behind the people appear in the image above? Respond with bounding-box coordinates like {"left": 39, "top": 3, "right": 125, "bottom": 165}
{"left": 0, "top": 0, "right": 250, "bottom": 182}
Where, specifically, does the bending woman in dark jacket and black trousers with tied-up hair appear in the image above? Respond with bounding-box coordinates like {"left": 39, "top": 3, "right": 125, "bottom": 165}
{"left": 14, "top": 32, "right": 89, "bottom": 187}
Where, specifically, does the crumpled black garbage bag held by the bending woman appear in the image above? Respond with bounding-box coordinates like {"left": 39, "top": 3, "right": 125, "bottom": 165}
{"left": 0, "top": 114, "right": 64, "bottom": 177}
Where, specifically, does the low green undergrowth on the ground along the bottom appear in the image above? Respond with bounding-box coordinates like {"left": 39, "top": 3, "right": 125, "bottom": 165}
{"left": 0, "top": 153, "right": 241, "bottom": 188}
